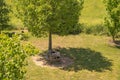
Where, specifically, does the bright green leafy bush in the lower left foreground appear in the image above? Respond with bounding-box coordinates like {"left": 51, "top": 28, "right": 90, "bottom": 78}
{"left": 0, "top": 34, "right": 38, "bottom": 80}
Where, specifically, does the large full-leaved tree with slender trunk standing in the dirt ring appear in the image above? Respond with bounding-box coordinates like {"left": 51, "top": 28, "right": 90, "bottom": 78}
{"left": 14, "top": 0, "right": 84, "bottom": 56}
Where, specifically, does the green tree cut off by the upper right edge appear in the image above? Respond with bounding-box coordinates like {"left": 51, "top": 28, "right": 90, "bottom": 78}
{"left": 104, "top": 0, "right": 120, "bottom": 41}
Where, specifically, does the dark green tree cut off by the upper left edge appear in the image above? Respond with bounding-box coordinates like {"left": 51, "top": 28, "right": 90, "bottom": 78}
{"left": 0, "top": 0, "right": 10, "bottom": 32}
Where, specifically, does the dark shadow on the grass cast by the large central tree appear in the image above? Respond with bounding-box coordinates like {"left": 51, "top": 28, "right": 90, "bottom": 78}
{"left": 60, "top": 48, "right": 112, "bottom": 72}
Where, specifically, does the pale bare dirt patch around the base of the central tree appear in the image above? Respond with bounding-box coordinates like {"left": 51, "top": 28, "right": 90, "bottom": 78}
{"left": 32, "top": 56, "right": 74, "bottom": 68}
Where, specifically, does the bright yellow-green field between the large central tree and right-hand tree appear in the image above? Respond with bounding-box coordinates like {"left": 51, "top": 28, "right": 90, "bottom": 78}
{"left": 80, "top": 0, "right": 106, "bottom": 25}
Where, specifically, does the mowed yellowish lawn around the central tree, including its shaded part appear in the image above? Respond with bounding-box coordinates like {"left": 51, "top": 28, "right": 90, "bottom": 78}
{"left": 26, "top": 34, "right": 120, "bottom": 80}
